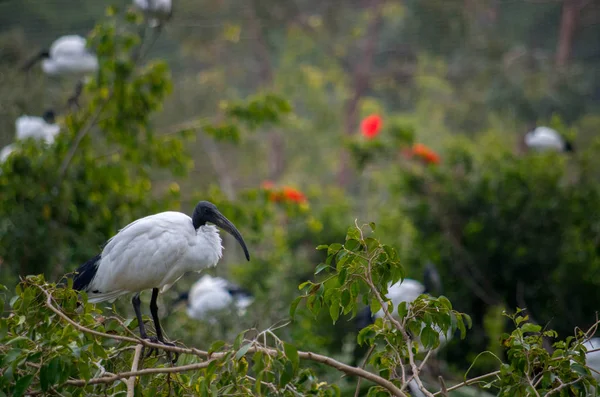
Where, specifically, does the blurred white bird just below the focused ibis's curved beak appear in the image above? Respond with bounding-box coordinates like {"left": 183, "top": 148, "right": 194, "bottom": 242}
{"left": 175, "top": 274, "right": 254, "bottom": 323}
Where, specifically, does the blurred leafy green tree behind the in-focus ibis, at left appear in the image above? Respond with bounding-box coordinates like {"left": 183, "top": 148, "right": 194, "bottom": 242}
{"left": 0, "top": 10, "right": 190, "bottom": 284}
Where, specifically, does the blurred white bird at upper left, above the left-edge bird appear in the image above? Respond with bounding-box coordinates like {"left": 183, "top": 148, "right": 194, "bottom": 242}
{"left": 23, "top": 35, "right": 98, "bottom": 76}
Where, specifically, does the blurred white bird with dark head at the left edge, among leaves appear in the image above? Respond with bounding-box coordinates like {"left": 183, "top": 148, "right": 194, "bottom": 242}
{"left": 0, "top": 110, "right": 60, "bottom": 163}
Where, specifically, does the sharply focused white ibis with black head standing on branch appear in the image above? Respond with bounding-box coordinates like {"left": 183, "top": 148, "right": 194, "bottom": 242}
{"left": 73, "top": 201, "right": 250, "bottom": 358}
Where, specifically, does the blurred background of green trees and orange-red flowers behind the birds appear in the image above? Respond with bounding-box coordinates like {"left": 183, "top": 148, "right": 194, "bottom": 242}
{"left": 0, "top": 0, "right": 600, "bottom": 391}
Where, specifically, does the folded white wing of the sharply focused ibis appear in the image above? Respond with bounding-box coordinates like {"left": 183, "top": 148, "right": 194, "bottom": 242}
{"left": 86, "top": 212, "right": 195, "bottom": 303}
